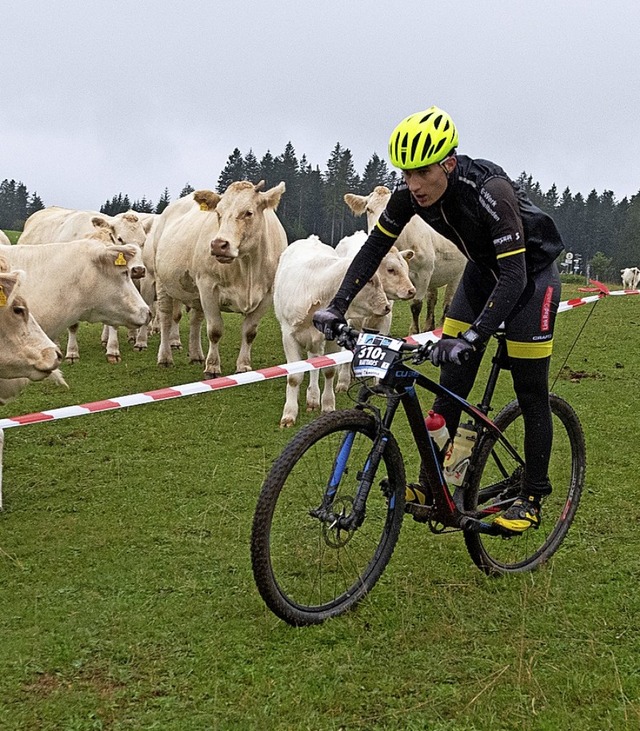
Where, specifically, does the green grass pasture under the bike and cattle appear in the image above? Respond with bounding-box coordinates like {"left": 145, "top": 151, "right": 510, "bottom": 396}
{"left": 0, "top": 287, "right": 640, "bottom": 731}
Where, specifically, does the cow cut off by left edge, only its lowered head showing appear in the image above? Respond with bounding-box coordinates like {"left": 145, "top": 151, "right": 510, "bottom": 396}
{"left": 0, "top": 255, "right": 62, "bottom": 381}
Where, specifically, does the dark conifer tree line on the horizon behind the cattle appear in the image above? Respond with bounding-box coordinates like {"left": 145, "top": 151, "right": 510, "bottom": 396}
{"left": 0, "top": 142, "right": 640, "bottom": 281}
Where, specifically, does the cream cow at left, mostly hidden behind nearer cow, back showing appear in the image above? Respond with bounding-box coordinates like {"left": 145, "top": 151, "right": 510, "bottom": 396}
{"left": 18, "top": 206, "right": 154, "bottom": 363}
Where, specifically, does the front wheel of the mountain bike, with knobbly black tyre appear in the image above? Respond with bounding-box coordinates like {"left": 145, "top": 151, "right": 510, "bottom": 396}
{"left": 251, "top": 409, "right": 405, "bottom": 626}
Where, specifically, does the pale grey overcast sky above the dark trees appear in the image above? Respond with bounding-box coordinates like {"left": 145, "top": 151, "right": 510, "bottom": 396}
{"left": 0, "top": 0, "right": 640, "bottom": 209}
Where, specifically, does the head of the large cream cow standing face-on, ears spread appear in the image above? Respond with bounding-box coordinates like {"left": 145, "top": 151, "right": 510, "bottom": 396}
{"left": 211, "top": 180, "right": 285, "bottom": 264}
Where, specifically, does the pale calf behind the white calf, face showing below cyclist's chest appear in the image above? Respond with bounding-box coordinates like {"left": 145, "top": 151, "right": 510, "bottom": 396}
{"left": 335, "top": 231, "right": 416, "bottom": 391}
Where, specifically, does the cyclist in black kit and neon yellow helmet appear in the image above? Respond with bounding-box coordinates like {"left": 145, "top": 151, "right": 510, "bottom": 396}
{"left": 313, "top": 107, "right": 564, "bottom": 533}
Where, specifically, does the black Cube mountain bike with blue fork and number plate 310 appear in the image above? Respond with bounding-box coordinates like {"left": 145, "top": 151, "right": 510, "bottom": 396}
{"left": 251, "top": 325, "right": 586, "bottom": 626}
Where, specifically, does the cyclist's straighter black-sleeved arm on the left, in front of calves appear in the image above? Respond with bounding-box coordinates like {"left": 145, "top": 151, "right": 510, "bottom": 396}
{"left": 330, "top": 188, "right": 414, "bottom": 315}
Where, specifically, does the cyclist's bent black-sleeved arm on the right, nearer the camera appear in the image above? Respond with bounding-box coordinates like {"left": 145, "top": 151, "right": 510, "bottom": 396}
{"left": 472, "top": 178, "right": 527, "bottom": 341}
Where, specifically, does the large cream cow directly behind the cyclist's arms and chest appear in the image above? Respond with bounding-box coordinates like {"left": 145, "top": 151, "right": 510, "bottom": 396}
{"left": 344, "top": 185, "right": 467, "bottom": 334}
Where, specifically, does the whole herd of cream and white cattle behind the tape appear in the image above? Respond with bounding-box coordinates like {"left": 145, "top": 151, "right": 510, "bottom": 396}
{"left": 0, "top": 181, "right": 640, "bottom": 426}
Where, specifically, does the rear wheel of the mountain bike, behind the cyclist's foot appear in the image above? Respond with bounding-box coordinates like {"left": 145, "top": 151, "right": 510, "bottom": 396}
{"left": 464, "top": 394, "right": 586, "bottom": 575}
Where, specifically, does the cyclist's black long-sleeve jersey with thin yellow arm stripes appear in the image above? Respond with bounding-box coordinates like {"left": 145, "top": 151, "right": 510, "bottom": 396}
{"left": 332, "top": 155, "right": 564, "bottom": 340}
